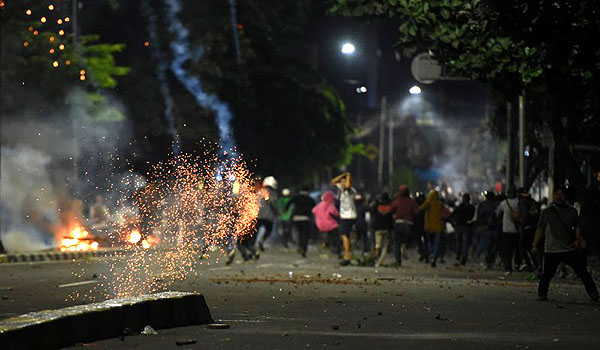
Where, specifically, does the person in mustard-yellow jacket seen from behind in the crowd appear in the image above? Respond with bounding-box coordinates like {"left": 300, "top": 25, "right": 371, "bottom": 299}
{"left": 419, "top": 189, "right": 444, "bottom": 267}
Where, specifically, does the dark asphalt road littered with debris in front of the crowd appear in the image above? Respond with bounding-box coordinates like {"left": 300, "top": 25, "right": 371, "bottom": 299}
{"left": 0, "top": 247, "right": 600, "bottom": 349}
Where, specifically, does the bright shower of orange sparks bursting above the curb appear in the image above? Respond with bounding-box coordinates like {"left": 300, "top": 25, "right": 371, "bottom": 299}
{"left": 74, "top": 148, "right": 260, "bottom": 298}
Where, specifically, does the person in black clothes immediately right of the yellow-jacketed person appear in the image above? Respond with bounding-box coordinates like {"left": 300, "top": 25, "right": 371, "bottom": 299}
{"left": 449, "top": 193, "right": 475, "bottom": 265}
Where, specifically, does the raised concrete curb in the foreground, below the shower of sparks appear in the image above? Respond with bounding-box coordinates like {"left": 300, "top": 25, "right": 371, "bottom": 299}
{"left": 0, "top": 292, "right": 213, "bottom": 349}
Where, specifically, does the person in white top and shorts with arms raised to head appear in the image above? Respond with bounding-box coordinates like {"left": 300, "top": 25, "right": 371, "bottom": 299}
{"left": 331, "top": 172, "right": 358, "bottom": 266}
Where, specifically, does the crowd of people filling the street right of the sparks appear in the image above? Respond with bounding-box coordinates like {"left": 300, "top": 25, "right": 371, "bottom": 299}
{"left": 227, "top": 172, "right": 600, "bottom": 300}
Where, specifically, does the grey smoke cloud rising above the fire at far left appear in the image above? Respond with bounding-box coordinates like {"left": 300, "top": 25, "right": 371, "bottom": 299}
{"left": 0, "top": 90, "right": 131, "bottom": 253}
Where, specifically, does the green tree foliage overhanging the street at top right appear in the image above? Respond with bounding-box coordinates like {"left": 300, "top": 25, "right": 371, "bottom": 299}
{"left": 331, "top": 0, "right": 599, "bottom": 84}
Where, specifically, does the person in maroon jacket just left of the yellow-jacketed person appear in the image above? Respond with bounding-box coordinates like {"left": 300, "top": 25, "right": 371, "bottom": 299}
{"left": 391, "top": 185, "right": 426, "bottom": 265}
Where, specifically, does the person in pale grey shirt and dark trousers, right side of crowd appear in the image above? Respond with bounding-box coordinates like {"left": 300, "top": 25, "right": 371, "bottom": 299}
{"left": 496, "top": 188, "right": 519, "bottom": 276}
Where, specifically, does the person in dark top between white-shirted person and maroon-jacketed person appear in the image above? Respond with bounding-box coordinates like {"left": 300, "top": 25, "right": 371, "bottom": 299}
{"left": 371, "top": 193, "right": 394, "bottom": 266}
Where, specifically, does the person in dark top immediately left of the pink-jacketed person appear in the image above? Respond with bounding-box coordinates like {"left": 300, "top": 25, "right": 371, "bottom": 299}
{"left": 285, "top": 187, "right": 316, "bottom": 257}
